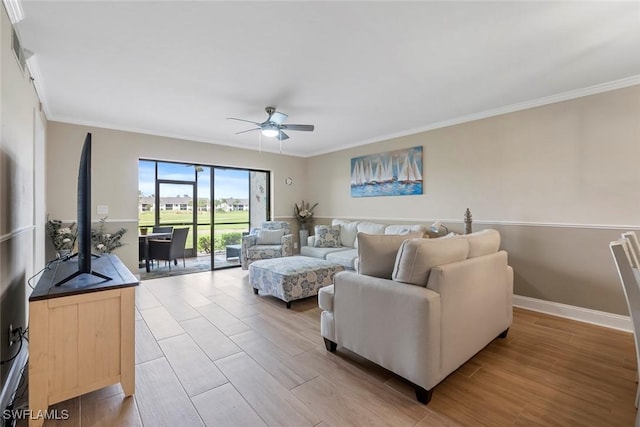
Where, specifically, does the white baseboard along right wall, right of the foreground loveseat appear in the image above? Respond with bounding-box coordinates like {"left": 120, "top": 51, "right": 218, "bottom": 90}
{"left": 513, "top": 295, "right": 633, "bottom": 332}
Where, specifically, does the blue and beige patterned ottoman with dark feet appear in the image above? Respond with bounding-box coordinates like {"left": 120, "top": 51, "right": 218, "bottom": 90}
{"left": 249, "top": 256, "right": 344, "bottom": 308}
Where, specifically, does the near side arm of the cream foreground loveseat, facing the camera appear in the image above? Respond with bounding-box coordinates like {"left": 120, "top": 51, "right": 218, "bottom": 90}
{"left": 333, "top": 271, "right": 441, "bottom": 390}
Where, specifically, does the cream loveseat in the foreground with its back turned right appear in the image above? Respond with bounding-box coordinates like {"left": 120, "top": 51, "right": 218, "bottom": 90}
{"left": 318, "top": 230, "right": 513, "bottom": 404}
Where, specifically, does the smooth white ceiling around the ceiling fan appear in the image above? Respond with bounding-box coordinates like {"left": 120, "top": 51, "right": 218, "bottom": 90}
{"left": 12, "top": 0, "right": 640, "bottom": 157}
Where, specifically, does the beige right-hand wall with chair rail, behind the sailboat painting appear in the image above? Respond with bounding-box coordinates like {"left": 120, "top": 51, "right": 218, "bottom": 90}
{"left": 307, "top": 86, "right": 640, "bottom": 314}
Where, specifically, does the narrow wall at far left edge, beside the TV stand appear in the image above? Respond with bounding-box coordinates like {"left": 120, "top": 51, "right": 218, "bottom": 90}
{"left": 0, "top": 6, "right": 45, "bottom": 379}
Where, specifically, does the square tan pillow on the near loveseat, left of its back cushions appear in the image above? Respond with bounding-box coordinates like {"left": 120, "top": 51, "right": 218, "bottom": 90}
{"left": 357, "top": 232, "right": 422, "bottom": 279}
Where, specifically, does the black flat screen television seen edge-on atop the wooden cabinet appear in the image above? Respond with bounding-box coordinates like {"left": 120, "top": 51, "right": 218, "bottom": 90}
{"left": 56, "top": 133, "right": 111, "bottom": 286}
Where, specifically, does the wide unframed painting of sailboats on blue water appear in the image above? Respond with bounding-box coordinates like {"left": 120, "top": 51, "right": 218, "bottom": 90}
{"left": 351, "top": 147, "right": 422, "bottom": 197}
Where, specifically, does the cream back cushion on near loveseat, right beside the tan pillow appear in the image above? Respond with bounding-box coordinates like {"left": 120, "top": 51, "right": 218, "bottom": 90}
{"left": 391, "top": 238, "right": 469, "bottom": 286}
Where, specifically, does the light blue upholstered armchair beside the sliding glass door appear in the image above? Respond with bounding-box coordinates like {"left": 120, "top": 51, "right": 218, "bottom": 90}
{"left": 240, "top": 221, "right": 293, "bottom": 270}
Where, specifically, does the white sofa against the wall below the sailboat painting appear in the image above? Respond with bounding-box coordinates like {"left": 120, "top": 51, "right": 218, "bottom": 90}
{"left": 300, "top": 219, "right": 427, "bottom": 270}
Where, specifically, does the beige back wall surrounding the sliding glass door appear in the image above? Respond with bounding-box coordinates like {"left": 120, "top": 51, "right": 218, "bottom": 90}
{"left": 47, "top": 121, "right": 307, "bottom": 272}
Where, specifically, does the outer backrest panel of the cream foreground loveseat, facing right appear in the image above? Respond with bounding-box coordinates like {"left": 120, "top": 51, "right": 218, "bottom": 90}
{"left": 427, "top": 251, "right": 513, "bottom": 375}
